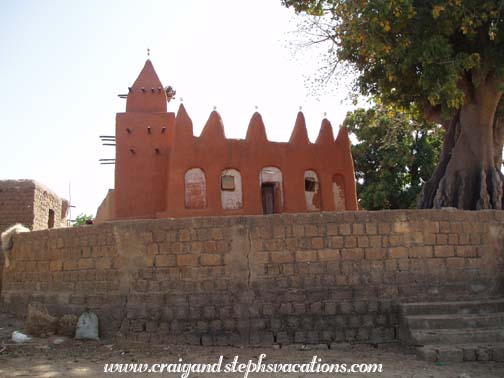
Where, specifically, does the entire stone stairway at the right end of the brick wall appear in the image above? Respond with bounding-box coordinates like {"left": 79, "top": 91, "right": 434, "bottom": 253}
{"left": 399, "top": 299, "right": 504, "bottom": 361}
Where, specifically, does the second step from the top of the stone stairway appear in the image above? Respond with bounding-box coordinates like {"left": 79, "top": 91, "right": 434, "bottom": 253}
{"left": 404, "top": 312, "right": 504, "bottom": 330}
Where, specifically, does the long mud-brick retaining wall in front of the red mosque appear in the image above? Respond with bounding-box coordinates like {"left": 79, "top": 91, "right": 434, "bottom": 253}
{"left": 1, "top": 210, "right": 504, "bottom": 345}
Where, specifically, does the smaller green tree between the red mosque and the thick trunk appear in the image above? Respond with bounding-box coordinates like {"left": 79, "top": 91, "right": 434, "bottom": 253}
{"left": 344, "top": 104, "right": 444, "bottom": 210}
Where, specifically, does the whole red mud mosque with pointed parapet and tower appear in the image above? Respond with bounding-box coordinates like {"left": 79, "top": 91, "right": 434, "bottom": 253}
{"left": 96, "top": 60, "right": 358, "bottom": 222}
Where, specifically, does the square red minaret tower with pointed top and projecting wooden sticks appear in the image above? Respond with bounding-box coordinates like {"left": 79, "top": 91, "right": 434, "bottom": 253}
{"left": 115, "top": 60, "right": 175, "bottom": 218}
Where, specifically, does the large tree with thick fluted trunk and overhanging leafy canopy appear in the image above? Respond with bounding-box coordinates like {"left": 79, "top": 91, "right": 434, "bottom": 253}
{"left": 282, "top": 0, "right": 504, "bottom": 209}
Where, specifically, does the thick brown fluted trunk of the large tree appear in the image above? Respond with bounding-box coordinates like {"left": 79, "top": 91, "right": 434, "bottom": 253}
{"left": 419, "top": 82, "right": 504, "bottom": 210}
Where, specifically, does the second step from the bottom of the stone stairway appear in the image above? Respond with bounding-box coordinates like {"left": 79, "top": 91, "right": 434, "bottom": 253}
{"left": 411, "top": 327, "right": 504, "bottom": 345}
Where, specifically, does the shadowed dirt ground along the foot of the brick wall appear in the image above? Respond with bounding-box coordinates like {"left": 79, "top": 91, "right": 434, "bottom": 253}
{"left": 0, "top": 314, "right": 504, "bottom": 378}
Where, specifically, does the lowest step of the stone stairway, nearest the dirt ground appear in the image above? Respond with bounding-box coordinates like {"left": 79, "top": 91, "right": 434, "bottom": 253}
{"left": 416, "top": 343, "right": 504, "bottom": 362}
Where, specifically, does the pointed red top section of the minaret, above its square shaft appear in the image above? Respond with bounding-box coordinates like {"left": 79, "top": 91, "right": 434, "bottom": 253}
{"left": 126, "top": 59, "right": 166, "bottom": 113}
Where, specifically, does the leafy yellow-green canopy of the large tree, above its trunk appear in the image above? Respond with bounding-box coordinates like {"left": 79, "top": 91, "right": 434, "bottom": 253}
{"left": 282, "top": 0, "right": 504, "bottom": 118}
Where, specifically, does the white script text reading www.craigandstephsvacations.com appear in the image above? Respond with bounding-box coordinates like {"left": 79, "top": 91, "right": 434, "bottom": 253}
{"left": 103, "top": 353, "right": 383, "bottom": 378}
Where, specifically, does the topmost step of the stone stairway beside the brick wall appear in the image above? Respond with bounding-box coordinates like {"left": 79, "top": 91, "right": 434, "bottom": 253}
{"left": 400, "top": 299, "right": 504, "bottom": 316}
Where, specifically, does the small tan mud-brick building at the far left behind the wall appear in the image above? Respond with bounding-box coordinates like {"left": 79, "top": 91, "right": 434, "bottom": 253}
{"left": 0, "top": 180, "right": 68, "bottom": 232}
